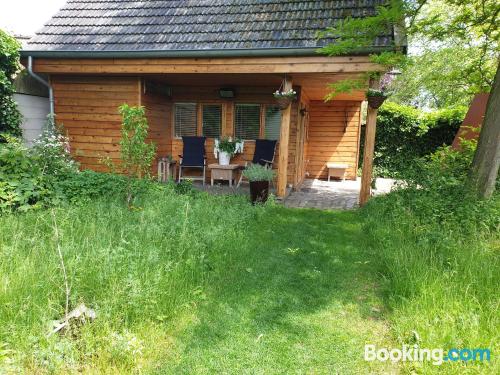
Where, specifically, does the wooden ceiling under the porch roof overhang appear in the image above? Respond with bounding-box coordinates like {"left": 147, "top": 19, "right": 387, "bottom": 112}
{"left": 144, "top": 73, "right": 364, "bottom": 100}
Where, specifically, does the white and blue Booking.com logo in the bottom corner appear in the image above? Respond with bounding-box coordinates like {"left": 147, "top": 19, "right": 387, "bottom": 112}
{"left": 365, "top": 344, "right": 491, "bottom": 366}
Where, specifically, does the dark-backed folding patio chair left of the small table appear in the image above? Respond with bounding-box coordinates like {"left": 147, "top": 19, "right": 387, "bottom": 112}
{"left": 179, "top": 137, "right": 207, "bottom": 186}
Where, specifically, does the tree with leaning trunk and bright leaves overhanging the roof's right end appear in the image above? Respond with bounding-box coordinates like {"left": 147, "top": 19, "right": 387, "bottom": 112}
{"left": 319, "top": 0, "right": 500, "bottom": 197}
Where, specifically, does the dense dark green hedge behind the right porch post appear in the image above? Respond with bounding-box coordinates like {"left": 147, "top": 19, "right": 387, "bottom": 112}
{"left": 360, "top": 103, "right": 466, "bottom": 178}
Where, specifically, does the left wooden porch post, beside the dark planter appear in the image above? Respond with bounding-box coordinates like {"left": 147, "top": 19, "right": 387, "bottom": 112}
{"left": 276, "top": 76, "right": 292, "bottom": 198}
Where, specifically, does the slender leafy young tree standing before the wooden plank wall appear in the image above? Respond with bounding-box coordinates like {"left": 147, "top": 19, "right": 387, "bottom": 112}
{"left": 119, "top": 104, "right": 156, "bottom": 207}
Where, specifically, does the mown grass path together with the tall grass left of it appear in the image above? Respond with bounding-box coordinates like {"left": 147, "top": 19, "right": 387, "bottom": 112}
{"left": 0, "top": 193, "right": 393, "bottom": 374}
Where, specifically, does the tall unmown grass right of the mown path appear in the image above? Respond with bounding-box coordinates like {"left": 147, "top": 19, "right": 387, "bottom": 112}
{"left": 364, "top": 188, "right": 500, "bottom": 374}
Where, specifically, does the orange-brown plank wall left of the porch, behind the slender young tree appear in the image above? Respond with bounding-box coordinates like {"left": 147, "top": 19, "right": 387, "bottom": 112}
{"left": 51, "top": 76, "right": 140, "bottom": 171}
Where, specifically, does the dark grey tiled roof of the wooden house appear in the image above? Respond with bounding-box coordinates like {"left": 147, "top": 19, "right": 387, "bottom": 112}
{"left": 25, "top": 0, "right": 394, "bottom": 51}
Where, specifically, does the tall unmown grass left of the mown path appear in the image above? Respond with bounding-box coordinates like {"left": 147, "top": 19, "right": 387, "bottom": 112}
{"left": 0, "top": 191, "right": 259, "bottom": 372}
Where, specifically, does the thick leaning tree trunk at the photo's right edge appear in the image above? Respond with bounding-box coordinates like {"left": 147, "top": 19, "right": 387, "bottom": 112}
{"left": 468, "top": 65, "right": 500, "bottom": 198}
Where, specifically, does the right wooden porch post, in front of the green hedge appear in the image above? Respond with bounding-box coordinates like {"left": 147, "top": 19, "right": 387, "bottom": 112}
{"left": 359, "top": 79, "right": 379, "bottom": 206}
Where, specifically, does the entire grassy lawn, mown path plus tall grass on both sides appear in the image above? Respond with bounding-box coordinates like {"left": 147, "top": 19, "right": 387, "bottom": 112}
{"left": 0, "top": 189, "right": 500, "bottom": 374}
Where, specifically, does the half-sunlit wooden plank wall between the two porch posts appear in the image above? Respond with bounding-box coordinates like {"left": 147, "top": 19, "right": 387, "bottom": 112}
{"left": 306, "top": 101, "right": 361, "bottom": 179}
